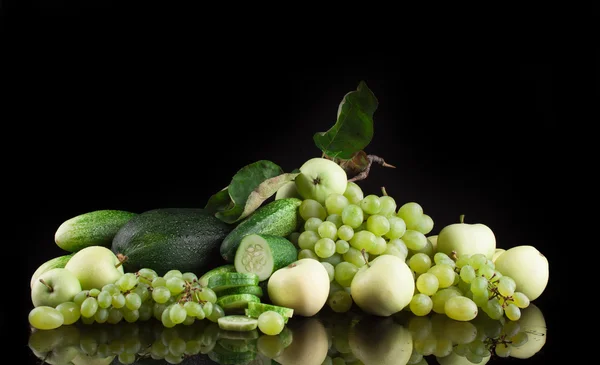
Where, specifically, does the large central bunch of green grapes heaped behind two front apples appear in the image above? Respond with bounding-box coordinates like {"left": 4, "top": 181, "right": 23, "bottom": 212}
{"left": 290, "top": 182, "right": 433, "bottom": 312}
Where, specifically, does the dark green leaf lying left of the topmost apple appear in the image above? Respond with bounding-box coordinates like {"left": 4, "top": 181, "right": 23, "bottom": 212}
{"left": 205, "top": 160, "right": 283, "bottom": 223}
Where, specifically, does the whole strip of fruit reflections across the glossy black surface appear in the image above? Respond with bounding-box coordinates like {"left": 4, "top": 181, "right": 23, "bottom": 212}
{"left": 29, "top": 304, "right": 546, "bottom": 365}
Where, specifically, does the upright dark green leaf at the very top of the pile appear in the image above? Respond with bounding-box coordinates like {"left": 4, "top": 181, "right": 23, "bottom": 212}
{"left": 313, "top": 81, "right": 379, "bottom": 159}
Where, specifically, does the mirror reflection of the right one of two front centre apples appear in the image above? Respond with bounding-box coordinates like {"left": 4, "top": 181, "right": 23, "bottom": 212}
{"left": 348, "top": 317, "right": 413, "bottom": 365}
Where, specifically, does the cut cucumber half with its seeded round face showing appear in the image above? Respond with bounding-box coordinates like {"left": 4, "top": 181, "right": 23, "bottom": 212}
{"left": 234, "top": 233, "right": 298, "bottom": 281}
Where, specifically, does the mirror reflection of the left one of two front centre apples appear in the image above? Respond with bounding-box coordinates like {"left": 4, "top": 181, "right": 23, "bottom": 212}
{"left": 273, "top": 316, "right": 329, "bottom": 365}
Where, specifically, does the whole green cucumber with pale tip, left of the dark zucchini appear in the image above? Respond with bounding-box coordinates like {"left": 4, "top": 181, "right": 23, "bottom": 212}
{"left": 54, "top": 209, "right": 137, "bottom": 252}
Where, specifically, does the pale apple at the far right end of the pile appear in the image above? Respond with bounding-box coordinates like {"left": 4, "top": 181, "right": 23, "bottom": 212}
{"left": 494, "top": 245, "right": 550, "bottom": 301}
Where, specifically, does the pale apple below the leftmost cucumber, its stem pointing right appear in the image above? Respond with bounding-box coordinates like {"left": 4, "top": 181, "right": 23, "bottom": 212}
{"left": 65, "top": 246, "right": 124, "bottom": 290}
